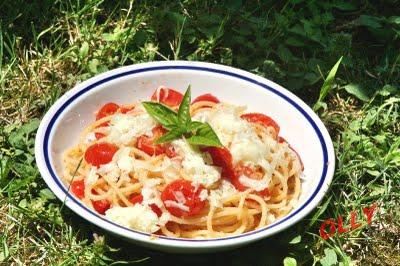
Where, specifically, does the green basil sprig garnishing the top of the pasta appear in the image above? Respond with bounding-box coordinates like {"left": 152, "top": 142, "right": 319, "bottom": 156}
{"left": 142, "top": 85, "right": 223, "bottom": 147}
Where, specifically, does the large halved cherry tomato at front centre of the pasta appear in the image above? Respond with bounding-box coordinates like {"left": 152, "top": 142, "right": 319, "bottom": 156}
{"left": 161, "top": 179, "right": 206, "bottom": 217}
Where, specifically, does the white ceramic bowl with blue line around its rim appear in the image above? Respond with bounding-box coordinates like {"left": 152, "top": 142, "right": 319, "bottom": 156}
{"left": 35, "top": 61, "right": 335, "bottom": 252}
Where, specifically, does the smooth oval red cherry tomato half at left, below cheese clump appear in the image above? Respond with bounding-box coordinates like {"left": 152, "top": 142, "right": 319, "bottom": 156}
{"left": 85, "top": 142, "right": 118, "bottom": 166}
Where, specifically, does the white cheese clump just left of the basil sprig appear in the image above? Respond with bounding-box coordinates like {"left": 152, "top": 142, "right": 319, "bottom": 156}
{"left": 107, "top": 113, "right": 156, "bottom": 144}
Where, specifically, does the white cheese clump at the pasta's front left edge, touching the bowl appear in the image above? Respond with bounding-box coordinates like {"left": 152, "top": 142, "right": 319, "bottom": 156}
{"left": 106, "top": 204, "right": 159, "bottom": 233}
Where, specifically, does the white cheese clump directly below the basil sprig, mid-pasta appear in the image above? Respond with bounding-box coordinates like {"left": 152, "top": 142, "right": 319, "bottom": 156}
{"left": 172, "top": 139, "right": 221, "bottom": 187}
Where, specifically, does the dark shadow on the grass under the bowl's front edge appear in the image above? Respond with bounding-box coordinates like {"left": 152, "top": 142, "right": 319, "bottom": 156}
{"left": 63, "top": 210, "right": 312, "bottom": 266}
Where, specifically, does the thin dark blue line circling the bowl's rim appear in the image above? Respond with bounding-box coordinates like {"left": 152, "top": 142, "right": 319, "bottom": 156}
{"left": 43, "top": 65, "right": 328, "bottom": 242}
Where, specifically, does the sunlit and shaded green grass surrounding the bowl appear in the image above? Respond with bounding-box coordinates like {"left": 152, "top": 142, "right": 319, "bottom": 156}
{"left": 0, "top": 0, "right": 400, "bottom": 266}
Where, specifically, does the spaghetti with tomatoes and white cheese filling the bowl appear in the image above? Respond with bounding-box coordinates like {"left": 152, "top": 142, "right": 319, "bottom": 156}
{"left": 63, "top": 87, "right": 303, "bottom": 238}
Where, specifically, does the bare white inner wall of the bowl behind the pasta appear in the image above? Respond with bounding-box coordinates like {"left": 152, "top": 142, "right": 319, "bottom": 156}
{"left": 50, "top": 70, "right": 324, "bottom": 210}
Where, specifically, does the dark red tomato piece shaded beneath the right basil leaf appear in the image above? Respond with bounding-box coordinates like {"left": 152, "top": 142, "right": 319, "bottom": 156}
{"left": 201, "top": 147, "right": 235, "bottom": 180}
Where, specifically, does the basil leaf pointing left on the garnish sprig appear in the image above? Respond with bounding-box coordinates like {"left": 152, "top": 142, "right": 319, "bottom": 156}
{"left": 142, "top": 102, "right": 178, "bottom": 129}
